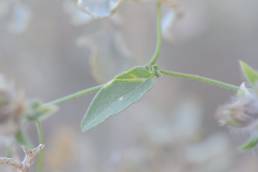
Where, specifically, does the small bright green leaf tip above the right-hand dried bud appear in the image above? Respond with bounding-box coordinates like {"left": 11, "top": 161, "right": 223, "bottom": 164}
{"left": 240, "top": 61, "right": 258, "bottom": 86}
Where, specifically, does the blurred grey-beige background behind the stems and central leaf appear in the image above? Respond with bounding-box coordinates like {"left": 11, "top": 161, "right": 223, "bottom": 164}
{"left": 0, "top": 0, "right": 258, "bottom": 172}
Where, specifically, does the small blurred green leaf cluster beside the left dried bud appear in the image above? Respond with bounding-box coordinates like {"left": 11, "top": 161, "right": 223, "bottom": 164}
{"left": 25, "top": 100, "right": 58, "bottom": 121}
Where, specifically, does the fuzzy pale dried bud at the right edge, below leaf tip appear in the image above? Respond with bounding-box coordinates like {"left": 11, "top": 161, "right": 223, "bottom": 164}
{"left": 218, "top": 84, "right": 258, "bottom": 150}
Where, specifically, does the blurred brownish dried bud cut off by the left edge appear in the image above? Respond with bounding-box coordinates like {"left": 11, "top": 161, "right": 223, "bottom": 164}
{"left": 0, "top": 75, "right": 26, "bottom": 136}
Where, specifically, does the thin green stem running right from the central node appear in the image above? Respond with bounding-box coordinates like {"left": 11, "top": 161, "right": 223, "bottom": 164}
{"left": 159, "top": 70, "right": 239, "bottom": 92}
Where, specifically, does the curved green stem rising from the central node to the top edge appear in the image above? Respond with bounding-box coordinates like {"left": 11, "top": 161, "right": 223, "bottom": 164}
{"left": 149, "top": 0, "right": 162, "bottom": 66}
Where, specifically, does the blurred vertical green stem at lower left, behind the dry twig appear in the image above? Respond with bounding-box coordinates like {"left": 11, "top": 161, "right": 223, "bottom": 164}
{"left": 35, "top": 121, "right": 45, "bottom": 172}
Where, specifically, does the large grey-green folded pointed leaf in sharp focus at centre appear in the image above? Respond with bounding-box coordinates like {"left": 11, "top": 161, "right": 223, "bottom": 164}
{"left": 81, "top": 67, "right": 154, "bottom": 132}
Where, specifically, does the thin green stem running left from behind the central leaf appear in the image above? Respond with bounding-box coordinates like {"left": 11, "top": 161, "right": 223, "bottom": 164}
{"left": 46, "top": 85, "right": 103, "bottom": 105}
